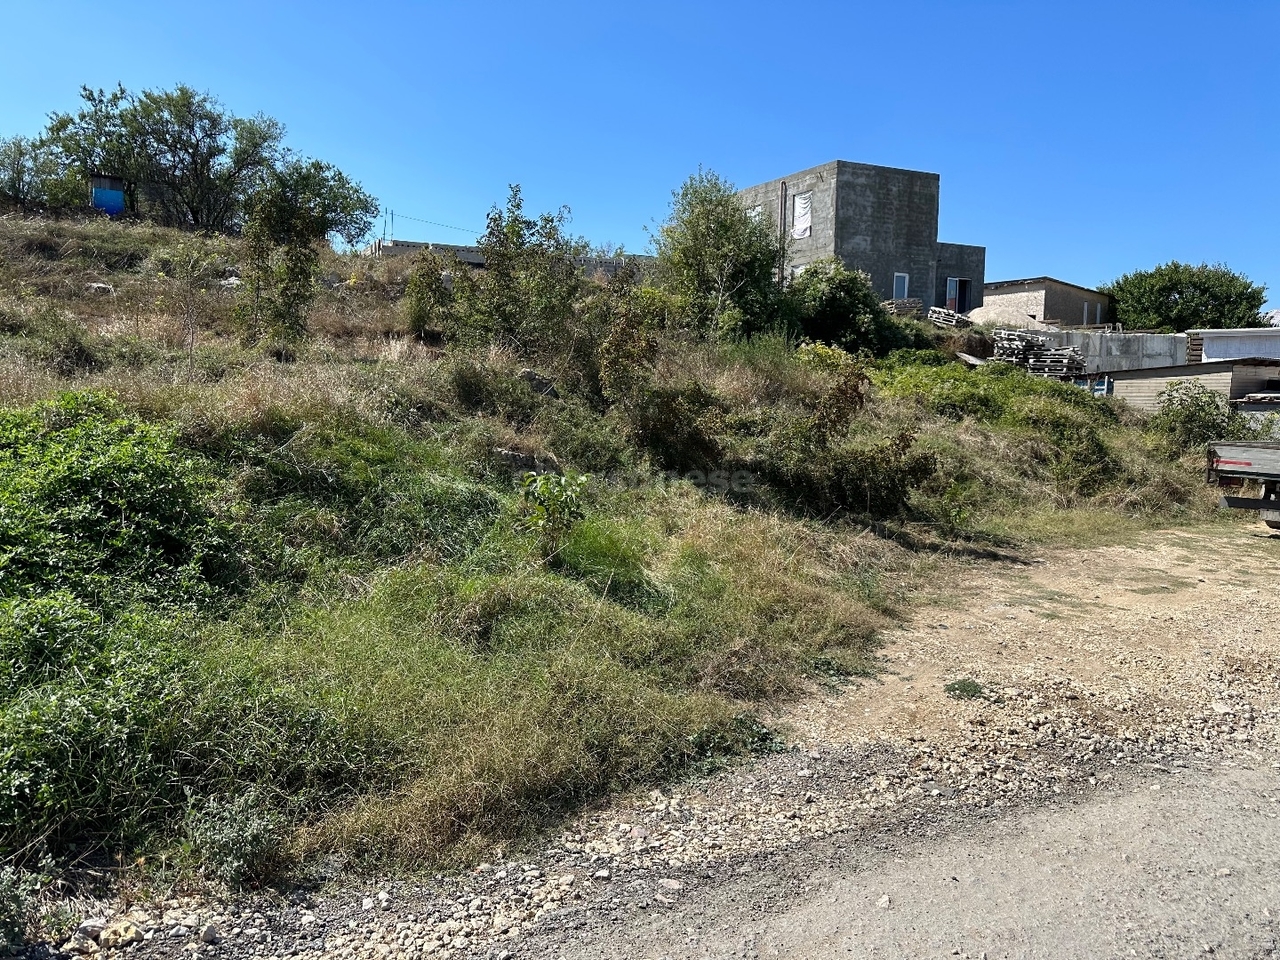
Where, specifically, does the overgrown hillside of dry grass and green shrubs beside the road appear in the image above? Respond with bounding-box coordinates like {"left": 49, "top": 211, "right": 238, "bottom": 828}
{"left": 0, "top": 220, "right": 1212, "bottom": 911}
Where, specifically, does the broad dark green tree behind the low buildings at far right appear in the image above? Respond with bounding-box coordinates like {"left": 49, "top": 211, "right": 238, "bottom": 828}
{"left": 1098, "top": 260, "right": 1267, "bottom": 333}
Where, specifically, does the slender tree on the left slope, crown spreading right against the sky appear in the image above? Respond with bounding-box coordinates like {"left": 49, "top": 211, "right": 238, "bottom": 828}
{"left": 237, "top": 159, "right": 378, "bottom": 342}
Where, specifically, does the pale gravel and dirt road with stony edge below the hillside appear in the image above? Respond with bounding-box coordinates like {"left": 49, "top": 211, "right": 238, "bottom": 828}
{"left": 46, "top": 526, "right": 1280, "bottom": 960}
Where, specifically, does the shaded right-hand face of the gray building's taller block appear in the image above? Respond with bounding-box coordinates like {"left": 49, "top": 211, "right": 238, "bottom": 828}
{"left": 819, "top": 160, "right": 940, "bottom": 303}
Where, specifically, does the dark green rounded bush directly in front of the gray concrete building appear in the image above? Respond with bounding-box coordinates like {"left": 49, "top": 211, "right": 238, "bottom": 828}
{"left": 786, "top": 257, "right": 915, "bottom": 357}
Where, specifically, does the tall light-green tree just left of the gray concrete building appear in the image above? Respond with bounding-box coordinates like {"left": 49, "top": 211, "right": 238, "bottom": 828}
{"left": 653, "top": 170, "right": 786, "bottom": 337}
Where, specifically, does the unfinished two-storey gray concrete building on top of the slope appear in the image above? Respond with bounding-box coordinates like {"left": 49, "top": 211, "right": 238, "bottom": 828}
{"left": 739, "top": 160, "right": 987, "bottom": 314}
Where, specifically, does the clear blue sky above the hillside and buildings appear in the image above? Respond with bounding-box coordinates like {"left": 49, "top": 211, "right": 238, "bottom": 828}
{"left": 0, "top": 0, "right": 1280, "bottom": 306}
